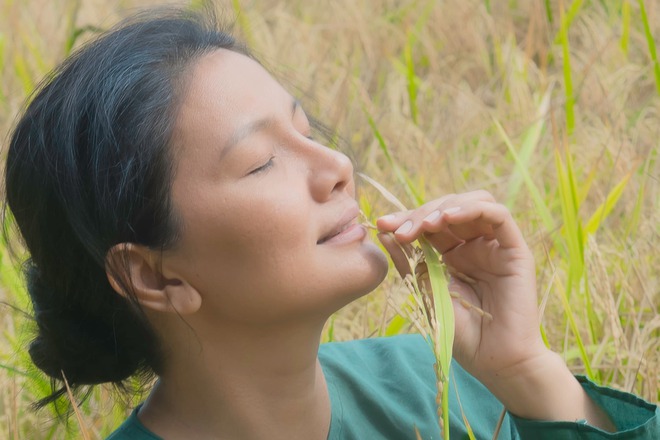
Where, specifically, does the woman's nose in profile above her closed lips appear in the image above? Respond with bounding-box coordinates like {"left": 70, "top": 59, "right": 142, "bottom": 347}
{"left": 309, "top": 144, "right": 355, "bottom": 202}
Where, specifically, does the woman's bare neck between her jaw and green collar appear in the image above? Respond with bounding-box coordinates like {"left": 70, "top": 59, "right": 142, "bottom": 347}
{"left": 140, "top": 316, "right": 330, "bottom": 439}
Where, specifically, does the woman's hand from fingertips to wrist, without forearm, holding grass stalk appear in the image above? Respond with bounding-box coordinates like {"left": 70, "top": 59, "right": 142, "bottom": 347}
{"left": 377, "top": 191, "right": 547, "bottom": 383}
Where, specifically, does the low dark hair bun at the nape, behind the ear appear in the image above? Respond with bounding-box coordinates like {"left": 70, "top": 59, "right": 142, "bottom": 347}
{"left": 26, "top": 262, "right": 153, "bottom": 386}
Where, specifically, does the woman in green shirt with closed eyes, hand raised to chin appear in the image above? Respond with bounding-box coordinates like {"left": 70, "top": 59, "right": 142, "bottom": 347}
{"left": 6, "top": 7, "right": 660, "bottom": 440}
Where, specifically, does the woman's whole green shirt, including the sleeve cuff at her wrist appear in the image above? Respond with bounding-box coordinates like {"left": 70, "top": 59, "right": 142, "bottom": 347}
{"left": 110, "top": 335, "right": 660, "bottom": 440}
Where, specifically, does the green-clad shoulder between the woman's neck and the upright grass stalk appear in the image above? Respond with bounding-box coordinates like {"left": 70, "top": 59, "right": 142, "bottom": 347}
{"left": 319, "top": 335, "right": 439, "bottom": 440}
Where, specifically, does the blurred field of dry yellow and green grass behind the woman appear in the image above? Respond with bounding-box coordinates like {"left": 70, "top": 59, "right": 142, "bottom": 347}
{"left": 0, "top": 0, "right": 660, "bottom": 439}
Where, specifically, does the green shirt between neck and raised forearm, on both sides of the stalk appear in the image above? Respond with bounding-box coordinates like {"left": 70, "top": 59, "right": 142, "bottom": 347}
{"left": 319, "top": 335, "right": 510, "bottom": 439}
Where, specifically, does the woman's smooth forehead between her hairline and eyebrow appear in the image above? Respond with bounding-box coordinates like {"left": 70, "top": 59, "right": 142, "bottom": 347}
{"left": 175, "top": 49, "right": 291, "bottom": 142}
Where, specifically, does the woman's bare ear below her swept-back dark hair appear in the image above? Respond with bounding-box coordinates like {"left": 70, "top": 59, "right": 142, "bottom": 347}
{"left": 105, "top": 243, "right": 202, "bottom": 315}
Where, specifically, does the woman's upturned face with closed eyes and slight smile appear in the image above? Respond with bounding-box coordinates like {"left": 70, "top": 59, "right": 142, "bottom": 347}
{"left": 163, "top": 49, "right": 387, "bottom": 324}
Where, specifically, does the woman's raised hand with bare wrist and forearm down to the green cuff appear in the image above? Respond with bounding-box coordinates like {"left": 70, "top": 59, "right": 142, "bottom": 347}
{"left": 377, "top": 191, "right": 614, "bottom": 430}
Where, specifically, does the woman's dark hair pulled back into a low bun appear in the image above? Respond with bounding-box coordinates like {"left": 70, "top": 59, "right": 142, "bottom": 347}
{"left": 5, "top": 9, "right": 246, "bottom": 406}
